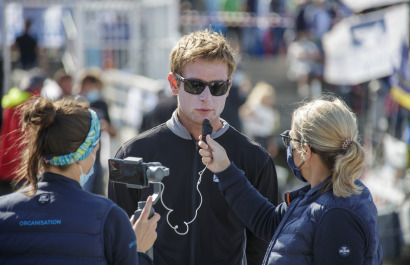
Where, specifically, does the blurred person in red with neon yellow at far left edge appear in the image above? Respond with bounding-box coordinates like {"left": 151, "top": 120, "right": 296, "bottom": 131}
{"left": 0, "top": 68, "right": 46, "bottom": 195}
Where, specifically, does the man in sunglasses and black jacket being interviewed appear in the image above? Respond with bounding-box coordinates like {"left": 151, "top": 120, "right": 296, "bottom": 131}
{"left": 108, "top": 29, "right": 278, "bottom": 265}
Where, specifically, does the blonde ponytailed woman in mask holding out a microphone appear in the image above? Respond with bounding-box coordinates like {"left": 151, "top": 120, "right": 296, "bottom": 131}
{"left": 199, "top": 97, "right": 383, "bottom": 265}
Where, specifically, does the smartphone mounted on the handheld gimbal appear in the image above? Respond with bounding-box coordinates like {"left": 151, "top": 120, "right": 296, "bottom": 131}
{"left": 108, "top": 158, "right": 148, "bottom": 187}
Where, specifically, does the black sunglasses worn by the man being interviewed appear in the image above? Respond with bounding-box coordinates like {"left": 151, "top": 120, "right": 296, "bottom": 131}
{"left": 175, "top": 73, "right": 230, "bottom": 96}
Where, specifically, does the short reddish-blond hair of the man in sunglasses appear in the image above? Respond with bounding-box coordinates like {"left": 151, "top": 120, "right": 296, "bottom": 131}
{"left": 169, "top": 29, "right": 238, "bottom": 77}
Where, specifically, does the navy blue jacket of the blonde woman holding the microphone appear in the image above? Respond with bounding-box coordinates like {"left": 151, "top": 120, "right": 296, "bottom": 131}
{"left": 216, "top": 164, "right": 382, "bottom": 265}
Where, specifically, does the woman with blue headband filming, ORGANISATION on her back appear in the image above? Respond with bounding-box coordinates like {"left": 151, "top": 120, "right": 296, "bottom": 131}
{"left": 0, "top": 98, "right": 160, "bottom": 265}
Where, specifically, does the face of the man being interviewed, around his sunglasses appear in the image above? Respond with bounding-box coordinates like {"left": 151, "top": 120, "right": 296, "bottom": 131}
{"left": 174, "top": 60, "right": 229, "bottom": 128}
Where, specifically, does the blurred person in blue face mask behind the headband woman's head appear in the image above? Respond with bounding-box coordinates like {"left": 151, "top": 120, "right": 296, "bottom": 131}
{"left": 80, "top": 70, "right": 117, "bottom": 196}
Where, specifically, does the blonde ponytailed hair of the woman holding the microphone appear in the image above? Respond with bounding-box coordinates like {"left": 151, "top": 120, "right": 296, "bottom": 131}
{"left": 292, "top": 95, "right": 365, "bottom": 197}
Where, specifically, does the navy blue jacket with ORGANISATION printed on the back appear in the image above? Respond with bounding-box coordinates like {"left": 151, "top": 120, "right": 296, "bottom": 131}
{"left": 0, "top": 173, "right": 149, "bottom": 265}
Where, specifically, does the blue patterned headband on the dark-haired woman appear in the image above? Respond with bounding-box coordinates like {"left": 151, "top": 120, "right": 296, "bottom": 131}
{"left": 44, "top": 109, "right": 101, "bottom": 166}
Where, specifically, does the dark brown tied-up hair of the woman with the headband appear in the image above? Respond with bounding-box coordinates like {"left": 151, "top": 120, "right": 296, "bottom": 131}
{"left": 17, "top": 98, "right": 91, "bottom": 195}
